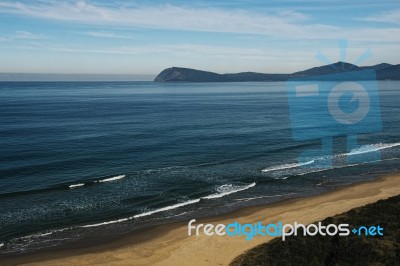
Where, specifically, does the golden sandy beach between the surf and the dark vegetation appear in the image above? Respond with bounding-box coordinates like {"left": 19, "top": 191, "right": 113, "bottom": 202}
{"left": 1, "top": 173, "right": 400, "bottom": 265}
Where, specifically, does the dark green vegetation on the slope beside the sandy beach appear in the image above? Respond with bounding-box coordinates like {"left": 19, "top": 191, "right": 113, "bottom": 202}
{"left": 230, "top": 195, "right": 400, "bottom": 266}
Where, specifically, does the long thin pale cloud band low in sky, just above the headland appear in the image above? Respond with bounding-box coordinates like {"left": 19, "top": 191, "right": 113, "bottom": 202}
{"left": 4, "top": 43, "right": 397, "bottom": 64}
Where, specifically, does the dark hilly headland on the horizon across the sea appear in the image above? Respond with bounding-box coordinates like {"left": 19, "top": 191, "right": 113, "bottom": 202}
{"left": 154, "top": 62, "right": 400, "bottom": 82}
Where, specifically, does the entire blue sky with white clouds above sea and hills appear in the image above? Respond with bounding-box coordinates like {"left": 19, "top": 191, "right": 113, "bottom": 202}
{"left": 0, "top": 0, "right": 400, "bottom": 75}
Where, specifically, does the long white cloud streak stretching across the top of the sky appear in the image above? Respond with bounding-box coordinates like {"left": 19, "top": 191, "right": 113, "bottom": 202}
{"left": 0, "top": 1, "right": 400, "bottom": 41}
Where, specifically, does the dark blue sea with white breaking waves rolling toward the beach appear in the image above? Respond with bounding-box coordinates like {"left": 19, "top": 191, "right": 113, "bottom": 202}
{"left": 0, "top": 81, "right": 400, "bottom": 254}
